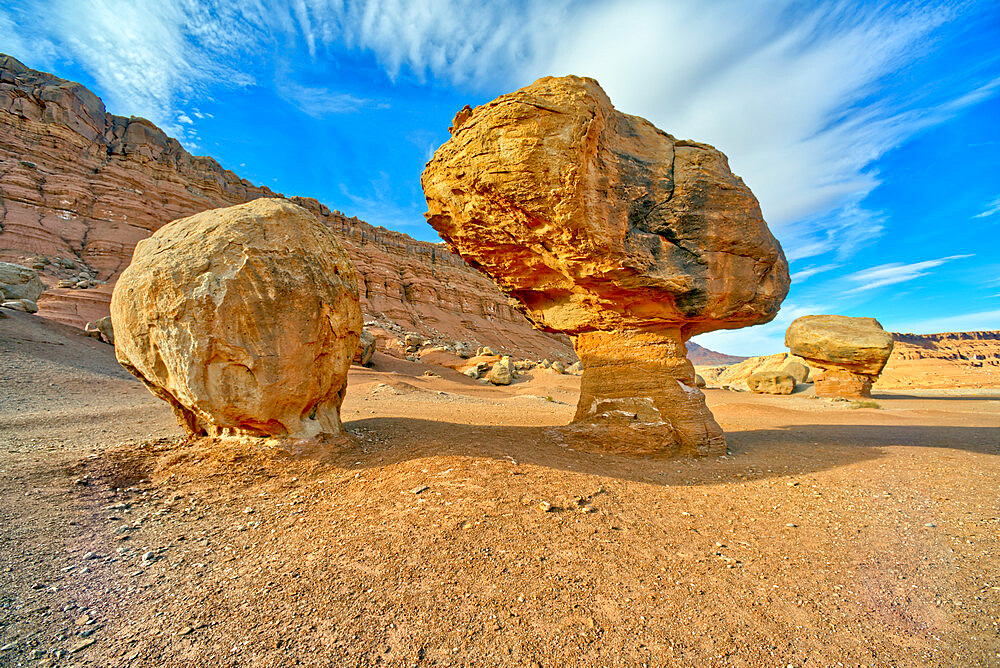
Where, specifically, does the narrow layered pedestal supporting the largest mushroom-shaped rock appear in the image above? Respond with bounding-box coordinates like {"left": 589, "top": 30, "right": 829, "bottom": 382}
{"left": 566, "top": 328, "right": 726, "bottom": 456}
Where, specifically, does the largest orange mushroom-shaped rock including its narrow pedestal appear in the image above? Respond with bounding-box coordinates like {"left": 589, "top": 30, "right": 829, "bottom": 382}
{"left": 421, "top": 76, "right": 789, "bottom": 454}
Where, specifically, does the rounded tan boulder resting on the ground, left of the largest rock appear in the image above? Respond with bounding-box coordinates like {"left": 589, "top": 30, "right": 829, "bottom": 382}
{"left": 111, "top": 199, "right": 361, "bottom": 438}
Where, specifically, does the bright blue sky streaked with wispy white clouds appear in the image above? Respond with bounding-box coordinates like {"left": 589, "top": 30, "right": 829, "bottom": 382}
{"left": 0, "top": 0, "right": 1000, "bottom": 355}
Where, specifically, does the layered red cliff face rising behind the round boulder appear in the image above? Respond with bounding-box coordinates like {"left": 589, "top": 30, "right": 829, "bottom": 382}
{"left": 0, "top": 56, "right": 571, "bottom": 357}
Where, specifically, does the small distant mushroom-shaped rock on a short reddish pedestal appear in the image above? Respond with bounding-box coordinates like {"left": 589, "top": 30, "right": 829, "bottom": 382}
{"left": 785, "top": 315, "right": 893, "bottom": 397}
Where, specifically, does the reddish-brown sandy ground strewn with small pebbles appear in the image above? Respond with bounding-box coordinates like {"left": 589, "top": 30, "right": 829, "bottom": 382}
{"left": 0, "top": 313, "right": 1000, "bottom": 667}
